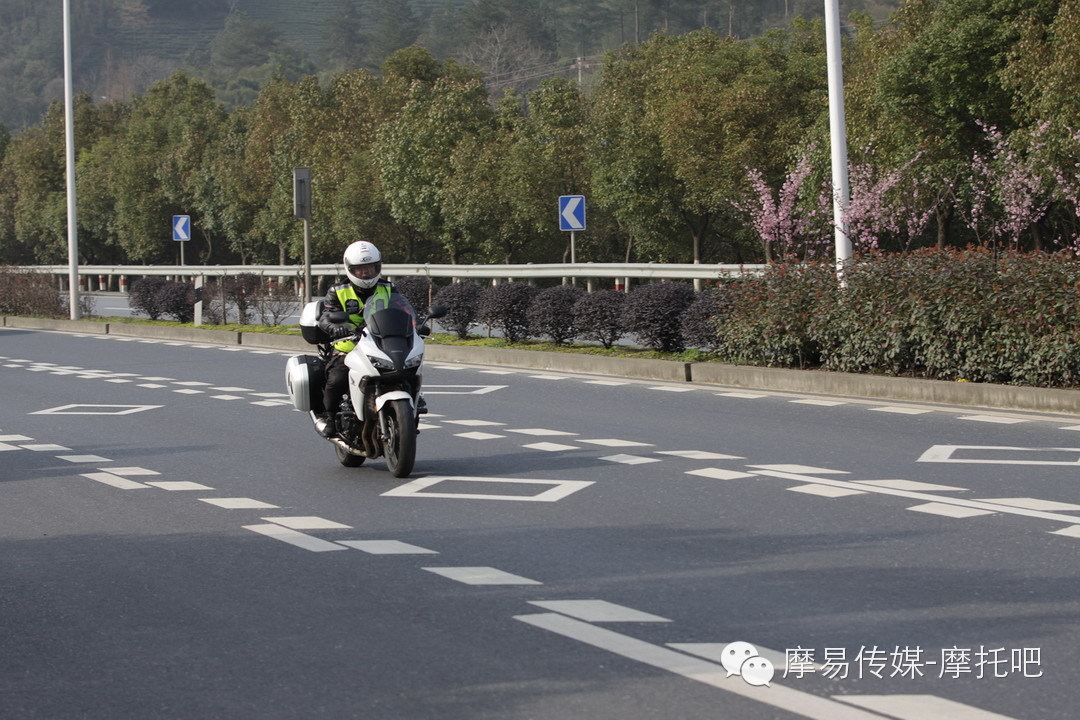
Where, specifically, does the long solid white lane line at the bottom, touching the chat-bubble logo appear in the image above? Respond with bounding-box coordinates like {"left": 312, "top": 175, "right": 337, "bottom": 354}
{"left": 514, "top": 613, "right": 881, "bottom": 720}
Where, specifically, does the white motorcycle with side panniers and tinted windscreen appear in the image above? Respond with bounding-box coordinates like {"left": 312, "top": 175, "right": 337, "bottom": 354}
{"left": 285, "top": 293, "right": 446, "bottom": 477}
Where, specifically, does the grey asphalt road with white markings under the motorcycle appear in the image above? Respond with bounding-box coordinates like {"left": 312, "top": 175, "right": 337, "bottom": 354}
{"left": 0, "top": 329, "right": 1080, "bottom": 720}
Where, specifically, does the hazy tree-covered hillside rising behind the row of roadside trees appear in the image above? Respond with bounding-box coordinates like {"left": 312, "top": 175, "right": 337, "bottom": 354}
{"left": 0, "top": 0, "right": 899, "bottom": 133}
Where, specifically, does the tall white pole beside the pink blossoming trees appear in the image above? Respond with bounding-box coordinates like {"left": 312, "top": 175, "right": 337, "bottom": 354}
{"left": 825, "top": 0, "right": 851, "bottom": 287}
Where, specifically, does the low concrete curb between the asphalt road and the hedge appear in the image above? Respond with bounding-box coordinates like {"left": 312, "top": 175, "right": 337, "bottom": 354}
{"left": 3, "top": 316, "right": 1080, "bottom": 415}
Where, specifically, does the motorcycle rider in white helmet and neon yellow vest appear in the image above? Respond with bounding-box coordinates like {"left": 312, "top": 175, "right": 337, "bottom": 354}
{"left": 315, "top": 240, "right": 394, "bottom": 437}
